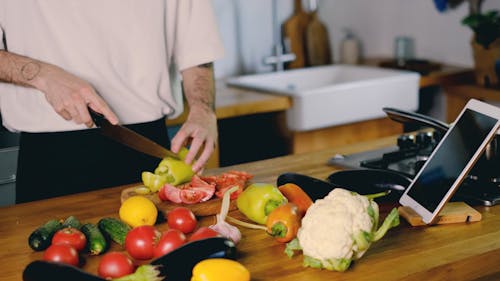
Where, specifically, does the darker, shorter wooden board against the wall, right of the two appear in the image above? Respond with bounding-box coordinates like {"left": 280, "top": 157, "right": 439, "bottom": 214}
{"left": 305, "top": 11, "right": 332, "bottom": 66}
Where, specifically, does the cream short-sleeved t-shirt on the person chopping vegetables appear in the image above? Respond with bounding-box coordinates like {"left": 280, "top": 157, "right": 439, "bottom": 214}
{"left": 0, "top": 0, "right": 223, "bottom": 132}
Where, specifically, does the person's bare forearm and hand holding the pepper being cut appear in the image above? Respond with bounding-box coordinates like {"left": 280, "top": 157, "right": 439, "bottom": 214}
{"left": 172, "top": 63, "right": 217, "bottom": 172}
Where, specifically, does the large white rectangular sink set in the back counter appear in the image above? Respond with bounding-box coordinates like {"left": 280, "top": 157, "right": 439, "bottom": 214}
{"left": 227, "top": 65, "right": 420, "bottom": 131}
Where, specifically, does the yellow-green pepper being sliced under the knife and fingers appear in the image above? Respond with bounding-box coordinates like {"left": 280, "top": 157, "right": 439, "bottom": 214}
{"left": 155, "top": 157, "right": 194, "bottom": 185}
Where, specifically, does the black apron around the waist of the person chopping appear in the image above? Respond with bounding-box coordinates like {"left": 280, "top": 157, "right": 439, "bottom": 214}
{"left": 16, "top": 118, "right": 170, "bottom": 203}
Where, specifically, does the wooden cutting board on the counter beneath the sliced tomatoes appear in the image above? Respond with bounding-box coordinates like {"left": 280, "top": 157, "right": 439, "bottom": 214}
{"left": 120, "top": 186, "right": 237, "bottom": 217}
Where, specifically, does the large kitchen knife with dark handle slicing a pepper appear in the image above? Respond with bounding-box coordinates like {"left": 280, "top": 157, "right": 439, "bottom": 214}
{"left": 89, "top": 108, "right": 180, "bottom": 159}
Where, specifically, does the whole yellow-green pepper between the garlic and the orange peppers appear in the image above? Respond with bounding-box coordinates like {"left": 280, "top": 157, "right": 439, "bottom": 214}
{"left": 236, "top": 183, "right": 287, "bottom": 224}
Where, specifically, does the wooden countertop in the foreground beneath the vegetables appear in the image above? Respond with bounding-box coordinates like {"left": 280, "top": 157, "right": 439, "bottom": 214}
{"left": 0, "top": 137, "right": 500, "bottom": 281}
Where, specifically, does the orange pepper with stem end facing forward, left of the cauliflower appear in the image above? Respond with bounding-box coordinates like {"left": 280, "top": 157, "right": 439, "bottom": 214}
{"left": 266, "top": 203, "right": 301, "bottom": 243}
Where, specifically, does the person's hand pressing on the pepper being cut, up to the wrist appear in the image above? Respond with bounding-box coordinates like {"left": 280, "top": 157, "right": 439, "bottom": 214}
{"left": 172, "top": 108, "right": 217, "bottom": 172}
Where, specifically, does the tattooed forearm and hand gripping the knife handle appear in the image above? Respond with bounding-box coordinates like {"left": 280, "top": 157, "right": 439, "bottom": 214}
{"left": 0, "top": 50, "right": 118, "bottom": 127}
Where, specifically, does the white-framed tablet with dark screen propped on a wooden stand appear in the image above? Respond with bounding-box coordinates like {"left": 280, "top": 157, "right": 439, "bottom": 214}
{"left": 399, "top": 99, "right": 500, "bottom": 224}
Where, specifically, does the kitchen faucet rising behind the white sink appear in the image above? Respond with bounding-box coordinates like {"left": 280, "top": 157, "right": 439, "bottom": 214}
{"left": 264, "top": 0, "right": 296, "bottom": 71}
